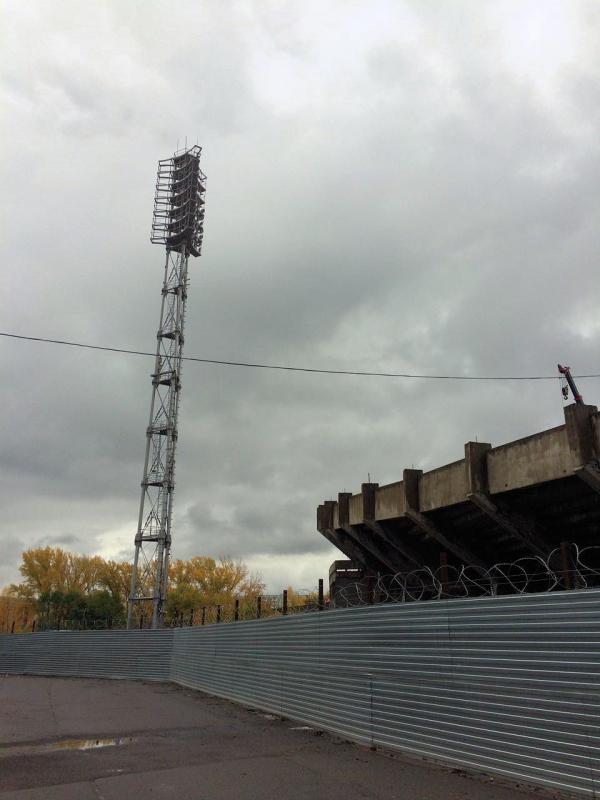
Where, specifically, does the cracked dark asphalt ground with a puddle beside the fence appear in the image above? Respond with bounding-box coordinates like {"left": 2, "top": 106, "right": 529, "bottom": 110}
{"left": 0, "top": 675, "right": 549, "bottom": 800}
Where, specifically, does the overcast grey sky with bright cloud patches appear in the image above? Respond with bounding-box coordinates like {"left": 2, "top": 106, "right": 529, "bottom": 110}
{"left": 0, "top": 0, "right": 600, "bottom": 591}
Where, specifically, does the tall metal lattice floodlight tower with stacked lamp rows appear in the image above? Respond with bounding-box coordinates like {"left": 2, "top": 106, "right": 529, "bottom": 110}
{"left": 127, "top": 145, "right": 206, "bottom": 628}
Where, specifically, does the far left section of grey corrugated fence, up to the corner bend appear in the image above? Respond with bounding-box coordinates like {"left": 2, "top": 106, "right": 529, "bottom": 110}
{"left": 0, "top": 630, "right": 173, "bottom": 681}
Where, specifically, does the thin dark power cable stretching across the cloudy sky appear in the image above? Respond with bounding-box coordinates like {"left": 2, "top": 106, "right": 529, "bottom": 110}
{"left": 0, "top": 331, "right": 600, "bottom": 381}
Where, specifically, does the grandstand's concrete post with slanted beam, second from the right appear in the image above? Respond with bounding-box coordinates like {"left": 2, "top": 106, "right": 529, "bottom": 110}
{"left": 465, "top": 442, "right": 552, "bottom": 557}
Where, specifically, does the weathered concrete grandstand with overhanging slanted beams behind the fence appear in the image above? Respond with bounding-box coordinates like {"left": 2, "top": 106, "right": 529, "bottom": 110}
{"left": 317, "top": 403, "right": 600, "bottom": 587}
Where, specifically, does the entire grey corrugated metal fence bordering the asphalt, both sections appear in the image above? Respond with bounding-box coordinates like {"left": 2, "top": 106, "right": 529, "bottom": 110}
{"left": 0, "top": 590, "right": 600, "bottom": 796}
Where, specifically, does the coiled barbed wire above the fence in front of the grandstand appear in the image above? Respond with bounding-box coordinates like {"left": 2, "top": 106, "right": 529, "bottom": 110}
{"left": 332, "top": 543, "right": 600, "bottom": 608}
